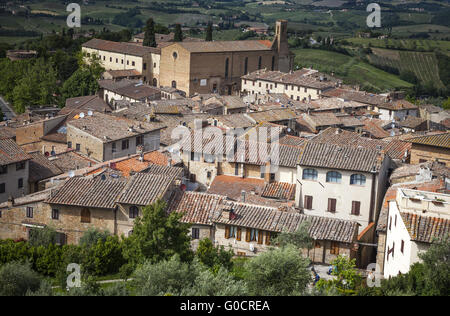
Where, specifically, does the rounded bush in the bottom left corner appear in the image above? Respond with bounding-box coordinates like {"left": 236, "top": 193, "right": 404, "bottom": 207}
{"left": 0, "top": 262, "right": 41, "bottom": 296}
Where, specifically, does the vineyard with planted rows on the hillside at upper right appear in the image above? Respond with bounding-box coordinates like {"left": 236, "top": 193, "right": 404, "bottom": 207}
{"left": 369, "top": 48, "right": 444, "bottom": 88}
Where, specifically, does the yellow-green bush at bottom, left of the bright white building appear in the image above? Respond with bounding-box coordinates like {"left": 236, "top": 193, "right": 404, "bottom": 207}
{"left": 316, "top": 255, "right": 362, "bottom": 295}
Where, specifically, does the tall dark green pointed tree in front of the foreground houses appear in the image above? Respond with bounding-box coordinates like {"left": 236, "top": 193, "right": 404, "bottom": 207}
{"left": 124, "top": 200, "right": 193, "bottom": 264}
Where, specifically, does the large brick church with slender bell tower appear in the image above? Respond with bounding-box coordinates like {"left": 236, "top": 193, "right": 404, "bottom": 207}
{"left": 160, "top": 21, "right": 294, "bottom": 96}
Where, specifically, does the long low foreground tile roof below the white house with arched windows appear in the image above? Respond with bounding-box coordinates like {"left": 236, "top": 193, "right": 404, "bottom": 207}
{"left": 213, "top": 202, "right": 359, "bottom": 243}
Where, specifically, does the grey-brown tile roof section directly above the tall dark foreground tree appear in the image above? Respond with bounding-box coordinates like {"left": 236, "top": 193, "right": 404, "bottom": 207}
{"left": 117, "top": 173, "right": 175, "bottom": 206}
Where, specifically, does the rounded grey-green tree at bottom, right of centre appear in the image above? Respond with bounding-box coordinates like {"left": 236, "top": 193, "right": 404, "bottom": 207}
{"left": 245, "top": 245, "right": 311, "bottom": 296}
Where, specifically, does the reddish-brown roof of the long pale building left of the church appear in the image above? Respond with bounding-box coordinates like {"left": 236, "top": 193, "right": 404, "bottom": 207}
{"left": 82, "top": 38, "right": 161, "bottom": 57}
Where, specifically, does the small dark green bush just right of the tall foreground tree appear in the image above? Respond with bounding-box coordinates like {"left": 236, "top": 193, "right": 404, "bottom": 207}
{"left": 196, "top": 238, "right": 234, "bottom": 270}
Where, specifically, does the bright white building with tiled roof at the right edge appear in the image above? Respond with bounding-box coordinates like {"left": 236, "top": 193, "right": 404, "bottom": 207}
{"left": 384, "top": 188, "right": 450, "bottom": 278}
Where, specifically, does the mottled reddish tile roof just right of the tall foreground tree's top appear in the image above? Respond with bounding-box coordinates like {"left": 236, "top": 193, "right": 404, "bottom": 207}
{"left": 167, "top": 191, "right": 226, "bottom": 225}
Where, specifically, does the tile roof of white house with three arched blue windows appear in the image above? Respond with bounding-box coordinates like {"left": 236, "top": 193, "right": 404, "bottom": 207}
{"left": 299, "top": 142, "right": 380, "bottom": 172}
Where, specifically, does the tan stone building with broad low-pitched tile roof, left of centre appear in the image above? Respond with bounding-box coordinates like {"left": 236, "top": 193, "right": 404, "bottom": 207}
{"left": 67, "top": 112, "right": 163, "bottom": 161}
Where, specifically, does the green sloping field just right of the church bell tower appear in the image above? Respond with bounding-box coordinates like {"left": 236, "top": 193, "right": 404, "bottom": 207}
{"left": 294, "top": 49, "right": 412, "bottom": 92}
